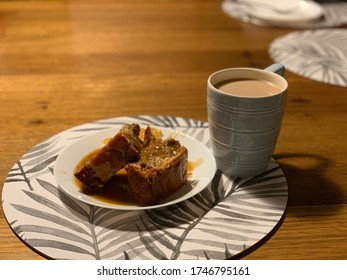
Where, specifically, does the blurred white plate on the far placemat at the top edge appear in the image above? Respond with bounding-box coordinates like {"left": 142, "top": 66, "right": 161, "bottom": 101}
{"left": 248, "top": 1, "right": 324, "bottom": 24}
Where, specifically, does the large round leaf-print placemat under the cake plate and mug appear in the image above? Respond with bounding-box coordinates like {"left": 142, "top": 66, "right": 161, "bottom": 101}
{"left": 2, "top": 116, "right": 288, "bottom": 260}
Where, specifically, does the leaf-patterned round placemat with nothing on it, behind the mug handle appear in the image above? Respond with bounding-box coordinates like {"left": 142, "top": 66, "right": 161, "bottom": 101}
{"left": 269, "top": 28, "right": 347, "bottom": 87}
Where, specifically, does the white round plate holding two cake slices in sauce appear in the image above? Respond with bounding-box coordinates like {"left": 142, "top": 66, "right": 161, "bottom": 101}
{"left": 54, "top": 125, "right": 216, "bottom": 210}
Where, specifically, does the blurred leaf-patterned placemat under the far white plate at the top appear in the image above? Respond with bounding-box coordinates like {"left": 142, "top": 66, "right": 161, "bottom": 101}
{"left": 222, "top": 0, "right": 347, "bottom": 29}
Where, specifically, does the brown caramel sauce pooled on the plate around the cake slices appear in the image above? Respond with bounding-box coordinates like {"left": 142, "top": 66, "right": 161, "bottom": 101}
{"left": 73, "top": 150, "right": 204, "bottom": 206}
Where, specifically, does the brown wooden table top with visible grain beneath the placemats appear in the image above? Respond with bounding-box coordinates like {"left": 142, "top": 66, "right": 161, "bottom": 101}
{"left": 0, "top": 0, "right": 347, "bottom": 259}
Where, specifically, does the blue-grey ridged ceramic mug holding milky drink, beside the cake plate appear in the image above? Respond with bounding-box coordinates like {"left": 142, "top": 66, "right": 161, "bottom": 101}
{"left": 207, "top": 64, "right": 288, "bottom": 177}
